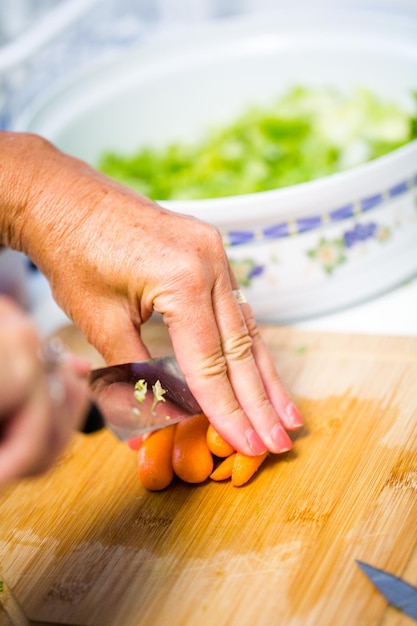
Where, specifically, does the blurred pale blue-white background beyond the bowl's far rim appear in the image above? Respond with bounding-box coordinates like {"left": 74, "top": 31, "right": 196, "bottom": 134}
{"left": 0, "top": 0, "right": 417, "bottom": 129}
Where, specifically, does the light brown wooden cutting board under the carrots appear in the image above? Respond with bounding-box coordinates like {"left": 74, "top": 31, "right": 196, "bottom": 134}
{"left": 0, "top": 325, "right": 417, "bottom": 626}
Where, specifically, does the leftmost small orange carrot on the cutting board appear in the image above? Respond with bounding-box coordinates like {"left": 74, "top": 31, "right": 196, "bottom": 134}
{"left": 138, "top": 424, "right": 176, "bottom": 491}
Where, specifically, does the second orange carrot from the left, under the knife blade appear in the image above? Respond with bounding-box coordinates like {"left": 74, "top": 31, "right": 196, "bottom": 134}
{"left": 172, "top": 413, "right": 213, "bottom": 483}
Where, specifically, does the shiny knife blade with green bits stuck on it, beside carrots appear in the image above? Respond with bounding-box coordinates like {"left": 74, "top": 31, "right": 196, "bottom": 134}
{"left": 89, "top": 356, "right": 202, "bottom": 441}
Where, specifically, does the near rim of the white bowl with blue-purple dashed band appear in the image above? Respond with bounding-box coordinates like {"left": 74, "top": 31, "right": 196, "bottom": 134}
{"left": 157, "top": 139, "right": 417, "bottom": 236}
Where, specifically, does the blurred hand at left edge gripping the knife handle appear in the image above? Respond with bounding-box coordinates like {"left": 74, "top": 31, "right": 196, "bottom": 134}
{"left": 0, "top": 297, "right": 88, "bottom": 487}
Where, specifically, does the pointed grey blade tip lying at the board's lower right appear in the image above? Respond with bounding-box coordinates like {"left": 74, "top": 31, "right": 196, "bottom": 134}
{"left": 356, "top": 561, "right": 417, "bottom": 620}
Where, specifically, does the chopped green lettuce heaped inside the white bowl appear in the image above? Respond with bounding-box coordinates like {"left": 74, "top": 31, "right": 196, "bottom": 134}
{"left": 98, "top": 87, "right": 417, "bottom": 200}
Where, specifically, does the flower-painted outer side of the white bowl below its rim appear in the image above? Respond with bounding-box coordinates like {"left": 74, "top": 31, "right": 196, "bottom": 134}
{"left": 226, "top": 177, "right": 417, "bottom": 322}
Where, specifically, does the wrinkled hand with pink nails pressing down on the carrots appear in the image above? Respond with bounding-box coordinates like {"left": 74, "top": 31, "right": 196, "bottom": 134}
{"left": 0, "top": 132, "right": 302, "bottom": 454}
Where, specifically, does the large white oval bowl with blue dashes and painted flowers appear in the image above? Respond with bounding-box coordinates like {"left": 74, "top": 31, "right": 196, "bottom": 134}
{"left": 17, "top": 9, "right": 417, "bottom": 322}
